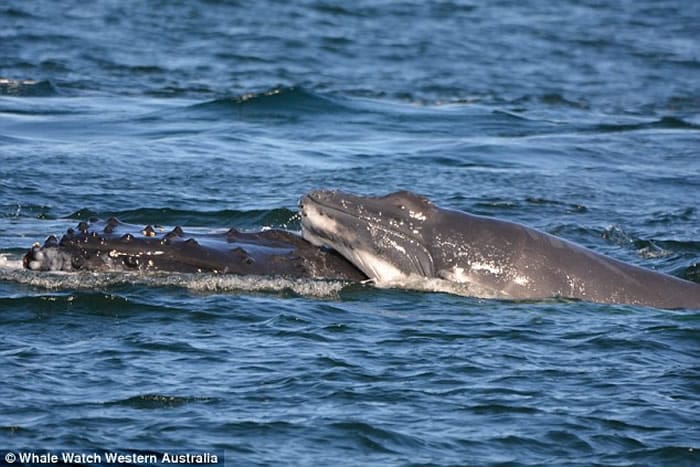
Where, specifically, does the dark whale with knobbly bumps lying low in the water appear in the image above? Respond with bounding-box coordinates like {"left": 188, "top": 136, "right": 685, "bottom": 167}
{"left": 23, "top": 218, "right": 366, "bottom": 281}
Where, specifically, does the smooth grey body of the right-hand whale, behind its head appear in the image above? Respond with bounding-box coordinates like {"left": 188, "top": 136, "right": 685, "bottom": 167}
{"left": 429, "top": 209, "right": 700, "bottom": 308}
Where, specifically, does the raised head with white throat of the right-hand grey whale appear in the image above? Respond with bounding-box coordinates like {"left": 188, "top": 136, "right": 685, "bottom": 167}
{"left": 299, "top": 190, "right": 436, "bottom": 283}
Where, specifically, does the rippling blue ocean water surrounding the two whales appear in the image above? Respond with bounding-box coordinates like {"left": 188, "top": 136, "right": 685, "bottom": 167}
{"left": 0, "top": 0, "right": 700, "bottom": 466}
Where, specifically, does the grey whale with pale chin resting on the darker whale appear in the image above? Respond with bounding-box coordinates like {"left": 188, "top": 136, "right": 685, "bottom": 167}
{"left": 300, "top": 190, "right": 700, "bottom": 308}
